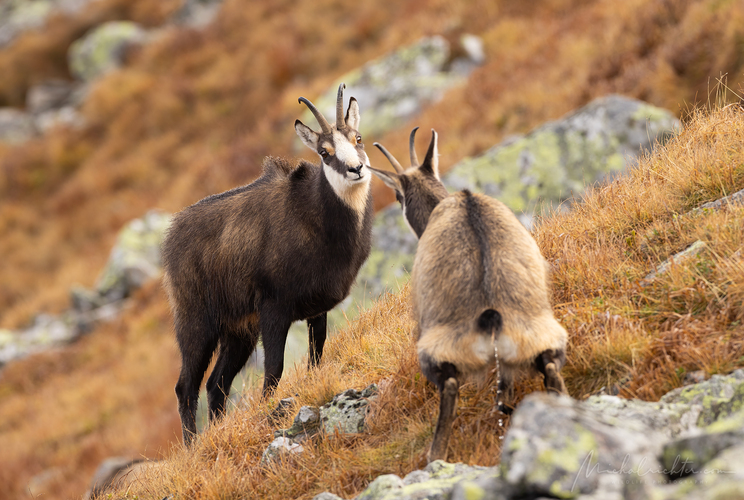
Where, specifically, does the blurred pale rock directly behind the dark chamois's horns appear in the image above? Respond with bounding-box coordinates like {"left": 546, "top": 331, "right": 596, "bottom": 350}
{"left": 302, "top": 35, "right": 485, "bottom": 140}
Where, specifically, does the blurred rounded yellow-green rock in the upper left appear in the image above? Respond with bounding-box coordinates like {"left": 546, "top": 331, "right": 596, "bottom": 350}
{"left": 67, "top": 21, "right": 147, "bottom": 81}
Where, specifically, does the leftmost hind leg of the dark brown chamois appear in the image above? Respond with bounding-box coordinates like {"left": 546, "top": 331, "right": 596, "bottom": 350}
{"left": 176, "top": 314, "right": 217, "bottom": 446}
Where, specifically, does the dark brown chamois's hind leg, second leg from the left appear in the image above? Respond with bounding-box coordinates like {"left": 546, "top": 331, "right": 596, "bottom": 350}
{"left": 207, "top": 332, "right": 258, "bottom": 421}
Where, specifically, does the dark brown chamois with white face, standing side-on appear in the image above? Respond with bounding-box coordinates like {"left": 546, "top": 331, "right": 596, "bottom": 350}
{"left": 163, "top": 84, "right": 373, "bottom": 446}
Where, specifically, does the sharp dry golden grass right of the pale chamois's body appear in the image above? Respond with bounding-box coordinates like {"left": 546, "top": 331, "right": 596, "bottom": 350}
{"left": 535, "top": 105, "right": 744, "bottom": 400}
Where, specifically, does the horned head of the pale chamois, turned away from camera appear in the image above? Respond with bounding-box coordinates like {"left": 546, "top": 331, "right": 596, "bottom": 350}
{"left": 370, "top": 127, "right": 449, "bottom": 238}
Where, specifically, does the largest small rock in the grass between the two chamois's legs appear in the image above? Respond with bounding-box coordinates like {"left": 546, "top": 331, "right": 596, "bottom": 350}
{"left": 320, "top": 384, "right": 378, "bottom": 435}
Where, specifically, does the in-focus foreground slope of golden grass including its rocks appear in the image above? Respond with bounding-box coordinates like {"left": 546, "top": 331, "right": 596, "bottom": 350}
{"left": 103, "top": 104, "right": 744, "bottom": 500}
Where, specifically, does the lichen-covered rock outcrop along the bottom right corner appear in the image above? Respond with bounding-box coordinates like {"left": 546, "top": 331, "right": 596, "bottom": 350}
{"left": 316, "top": 370, "right": 744, "bottom": 500}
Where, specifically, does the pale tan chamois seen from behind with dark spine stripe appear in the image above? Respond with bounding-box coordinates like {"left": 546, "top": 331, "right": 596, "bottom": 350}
{"left": 371, "top": 129, "right": 567, "bottom": 462}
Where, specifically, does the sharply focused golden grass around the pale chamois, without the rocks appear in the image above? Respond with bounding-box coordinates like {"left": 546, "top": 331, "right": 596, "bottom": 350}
{"left": 116, "top": 105, "right": 744, "bottom": 499}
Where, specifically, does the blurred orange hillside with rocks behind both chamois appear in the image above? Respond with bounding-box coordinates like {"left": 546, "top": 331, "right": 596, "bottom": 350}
{"left": 0, "top": 0, "right": 744, "bottom": 499}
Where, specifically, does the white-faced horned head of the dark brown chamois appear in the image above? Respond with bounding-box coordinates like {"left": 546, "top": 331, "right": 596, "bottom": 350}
{"left": 295, "top": 83, "right": 370, "bottom": 207}
